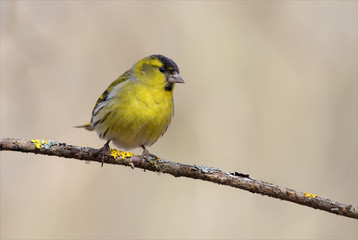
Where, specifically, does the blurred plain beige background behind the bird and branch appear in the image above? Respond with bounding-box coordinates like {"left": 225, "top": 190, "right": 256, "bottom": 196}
{"left": 0, "top": 1, "right": 358, "bottom": 239}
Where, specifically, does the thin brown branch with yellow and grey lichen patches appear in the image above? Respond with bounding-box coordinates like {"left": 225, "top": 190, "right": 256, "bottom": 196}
{"left": 0, "top": 138, "right": 358, "bottom": 219}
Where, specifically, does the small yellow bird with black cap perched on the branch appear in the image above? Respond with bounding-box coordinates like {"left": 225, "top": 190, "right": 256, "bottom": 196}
{"left": 77, "top": 54, "right": 184, "bottom": 166}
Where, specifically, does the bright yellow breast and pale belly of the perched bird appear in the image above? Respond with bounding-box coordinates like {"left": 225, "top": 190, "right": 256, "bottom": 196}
{"left": 93, "top": 79, "right": 173, "bottom": 149}
